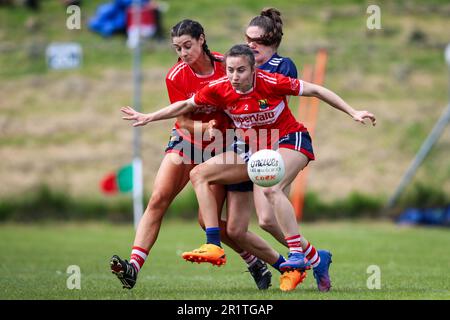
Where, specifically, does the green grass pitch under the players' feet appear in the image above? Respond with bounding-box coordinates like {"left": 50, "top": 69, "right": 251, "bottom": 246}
{"left": 0, "top": 220, "right": 450, "bottom": 300}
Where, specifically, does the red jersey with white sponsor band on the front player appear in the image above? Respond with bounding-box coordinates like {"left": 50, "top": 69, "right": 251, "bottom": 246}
{"left": 194, "top": 70, "right": 307, "bottom": 147}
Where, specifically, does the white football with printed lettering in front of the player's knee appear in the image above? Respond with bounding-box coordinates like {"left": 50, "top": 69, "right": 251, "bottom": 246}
{"left": 247, "top": 149, "right": 284, "bottom": 187}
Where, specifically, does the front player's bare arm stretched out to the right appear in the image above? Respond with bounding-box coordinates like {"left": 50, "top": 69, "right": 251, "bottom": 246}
{"left": 302, "top": 81, "right": 377, "bottom": 125}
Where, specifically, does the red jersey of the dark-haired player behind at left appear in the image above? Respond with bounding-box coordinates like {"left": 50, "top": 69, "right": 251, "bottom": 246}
{"left": 166, "top": 52, "right": 231, "bottom": 147}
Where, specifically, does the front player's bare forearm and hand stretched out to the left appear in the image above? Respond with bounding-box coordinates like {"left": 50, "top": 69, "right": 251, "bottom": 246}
{"left": 120, "top": 100, "right": 194, "bottom": 127}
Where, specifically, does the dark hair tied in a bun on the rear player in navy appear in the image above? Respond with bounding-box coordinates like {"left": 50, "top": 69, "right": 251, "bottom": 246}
{"left": 248, "top": 8, "right": 283, "bottom": 48}
